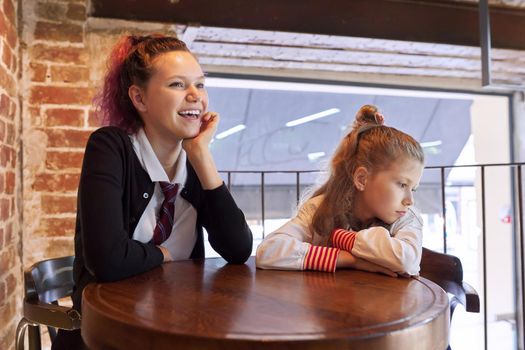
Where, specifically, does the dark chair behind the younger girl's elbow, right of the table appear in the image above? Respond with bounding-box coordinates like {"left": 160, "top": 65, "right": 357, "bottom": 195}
{"left": 420, "top": 248, "right": 479, "bottom": 349}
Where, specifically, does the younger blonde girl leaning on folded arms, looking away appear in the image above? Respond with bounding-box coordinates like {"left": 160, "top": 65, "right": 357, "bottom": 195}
{"left": 256, "top": 105, "right": 424, "bottom": 276}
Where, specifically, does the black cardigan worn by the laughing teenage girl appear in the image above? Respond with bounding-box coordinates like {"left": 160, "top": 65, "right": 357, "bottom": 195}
{"left": 73, "top": 127, "right": 253, "bottom": 310}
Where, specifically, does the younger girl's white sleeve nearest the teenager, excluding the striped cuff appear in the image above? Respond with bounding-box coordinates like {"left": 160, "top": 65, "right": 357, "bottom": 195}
{"left": 255, "top": 198, "right": 318, "bottom": 270}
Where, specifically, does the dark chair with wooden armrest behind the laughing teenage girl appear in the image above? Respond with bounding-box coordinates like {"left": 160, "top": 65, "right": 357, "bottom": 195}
{"left": 16, "top": 256, "right": 81, "bottom": 350}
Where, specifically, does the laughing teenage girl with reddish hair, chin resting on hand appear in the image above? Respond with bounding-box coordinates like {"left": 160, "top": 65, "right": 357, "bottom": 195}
{"left": 53, "top": 35, "right": 252, "bottom": 349}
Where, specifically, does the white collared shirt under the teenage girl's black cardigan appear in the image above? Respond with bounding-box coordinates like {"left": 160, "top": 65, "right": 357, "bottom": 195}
{"left": 130, "top": 128, "right": 197, "bottom": 260}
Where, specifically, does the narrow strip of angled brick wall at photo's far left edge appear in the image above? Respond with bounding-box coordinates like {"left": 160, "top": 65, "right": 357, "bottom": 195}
{"left": 0, "top": 0, "right": 22, "bottom": 349}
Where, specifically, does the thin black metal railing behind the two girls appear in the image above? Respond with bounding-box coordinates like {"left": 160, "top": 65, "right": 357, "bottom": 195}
{"left": 220, "top": 163, "right": 525, "bottom": 350}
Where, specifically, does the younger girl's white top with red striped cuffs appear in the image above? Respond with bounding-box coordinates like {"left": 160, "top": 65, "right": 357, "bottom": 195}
{"left": 256, "top": 195, "right": 423, "bottom": 275}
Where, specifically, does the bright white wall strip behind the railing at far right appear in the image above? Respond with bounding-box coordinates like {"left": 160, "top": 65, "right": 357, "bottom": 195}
{"left": 471, "top": 96, "right": 515, "bottom": 320}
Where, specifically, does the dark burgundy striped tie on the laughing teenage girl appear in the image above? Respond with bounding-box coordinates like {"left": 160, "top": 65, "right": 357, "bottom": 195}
{"left": 152, "top": 182, "right": 179, "bottom": 245}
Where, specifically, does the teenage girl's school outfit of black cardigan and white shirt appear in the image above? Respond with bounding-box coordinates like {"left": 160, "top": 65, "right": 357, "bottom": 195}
{"left": 53, "top": 127, "right": 253, "bottom": 350}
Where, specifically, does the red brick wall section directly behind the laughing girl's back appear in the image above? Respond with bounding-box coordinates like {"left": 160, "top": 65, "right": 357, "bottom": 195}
{"left": 22, "top": 0, "right": 93, "bottom": 267}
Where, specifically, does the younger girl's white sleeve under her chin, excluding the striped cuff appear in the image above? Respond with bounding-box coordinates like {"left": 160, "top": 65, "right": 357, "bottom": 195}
{"left": 352, "top": 208, "right": 423, "bottom": 275}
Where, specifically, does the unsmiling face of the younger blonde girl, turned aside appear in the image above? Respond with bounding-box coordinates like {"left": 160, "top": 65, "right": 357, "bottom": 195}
{"left": 354, "top": 158, "right": 423, "bottom": 224}
